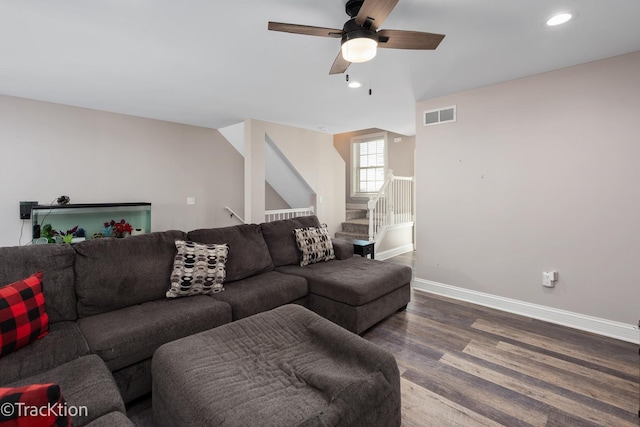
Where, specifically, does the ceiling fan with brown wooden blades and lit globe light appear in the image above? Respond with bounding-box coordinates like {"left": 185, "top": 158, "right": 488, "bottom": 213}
{"left": 269, "top": 0, "right": 444, "bottom": 74}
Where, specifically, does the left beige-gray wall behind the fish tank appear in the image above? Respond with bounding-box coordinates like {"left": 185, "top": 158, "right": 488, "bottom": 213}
{"left": 0, "top": 96, "right": 244, "bottom": 246}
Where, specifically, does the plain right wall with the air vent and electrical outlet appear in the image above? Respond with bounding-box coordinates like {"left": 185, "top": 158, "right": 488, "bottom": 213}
{"left": 416, "top": 52, "right": 640, "bottom": 325}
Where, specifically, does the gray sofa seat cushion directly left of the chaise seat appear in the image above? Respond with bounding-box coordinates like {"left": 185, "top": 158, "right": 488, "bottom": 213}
{"left": 211, "top": 271, "right": 309, "bottom": 320}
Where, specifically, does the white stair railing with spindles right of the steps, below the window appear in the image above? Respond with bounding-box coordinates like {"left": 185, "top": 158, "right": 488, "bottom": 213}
{"left": 367, "top": 170, "right": 414, "bottom": 243}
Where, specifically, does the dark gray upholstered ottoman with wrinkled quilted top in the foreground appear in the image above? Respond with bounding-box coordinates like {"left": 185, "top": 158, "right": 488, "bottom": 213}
{"left": 152, "top": 305, "right": 400, "bottom": 426}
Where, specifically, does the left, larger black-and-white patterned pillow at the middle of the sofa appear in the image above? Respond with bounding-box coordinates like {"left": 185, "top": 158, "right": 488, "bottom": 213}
{"left": 167, "top": 240, "right": 229, "bottom": 298}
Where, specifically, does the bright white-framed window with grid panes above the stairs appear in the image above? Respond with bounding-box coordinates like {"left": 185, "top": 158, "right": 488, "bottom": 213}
{"left": 351, "top": 133, "right": 387, "bottom": 196}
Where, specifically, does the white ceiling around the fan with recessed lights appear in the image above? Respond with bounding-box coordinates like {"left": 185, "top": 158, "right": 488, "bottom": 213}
{"left": 0, "top": 0, "right": 640, "bottom": 135}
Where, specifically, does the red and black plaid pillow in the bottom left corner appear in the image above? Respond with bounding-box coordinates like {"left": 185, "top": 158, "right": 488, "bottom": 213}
{"left": 0, "top": 384, "right": 72, "bottom": 427}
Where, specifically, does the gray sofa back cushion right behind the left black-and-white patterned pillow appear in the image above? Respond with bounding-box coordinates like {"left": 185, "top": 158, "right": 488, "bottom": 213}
{"left": 188, "top": 224, "right": 273, "bottom": 282}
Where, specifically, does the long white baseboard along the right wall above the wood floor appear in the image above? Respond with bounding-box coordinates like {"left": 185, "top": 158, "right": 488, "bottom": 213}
{"left": 412, "top": 280, "right": 640, "bottom": 344}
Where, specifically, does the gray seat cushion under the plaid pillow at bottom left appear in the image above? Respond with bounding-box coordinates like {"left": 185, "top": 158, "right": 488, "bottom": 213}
{"left": 8, "top": 355, "right": 125, "bottom": 427}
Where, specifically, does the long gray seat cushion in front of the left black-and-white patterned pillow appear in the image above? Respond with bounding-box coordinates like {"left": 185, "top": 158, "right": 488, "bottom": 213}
{"left": 78, "top": 296, "right": 231, "bottom": 371}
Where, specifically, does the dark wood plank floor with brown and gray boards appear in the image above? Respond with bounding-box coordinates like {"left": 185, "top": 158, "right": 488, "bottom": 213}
{"left": 363, "top": 253, "right": 640, "bottom": 427}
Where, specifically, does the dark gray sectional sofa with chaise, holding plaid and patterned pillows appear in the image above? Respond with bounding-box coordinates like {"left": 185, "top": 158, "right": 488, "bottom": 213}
{"left": 0, "top": 216, "right": 411, "bottom": 426}
